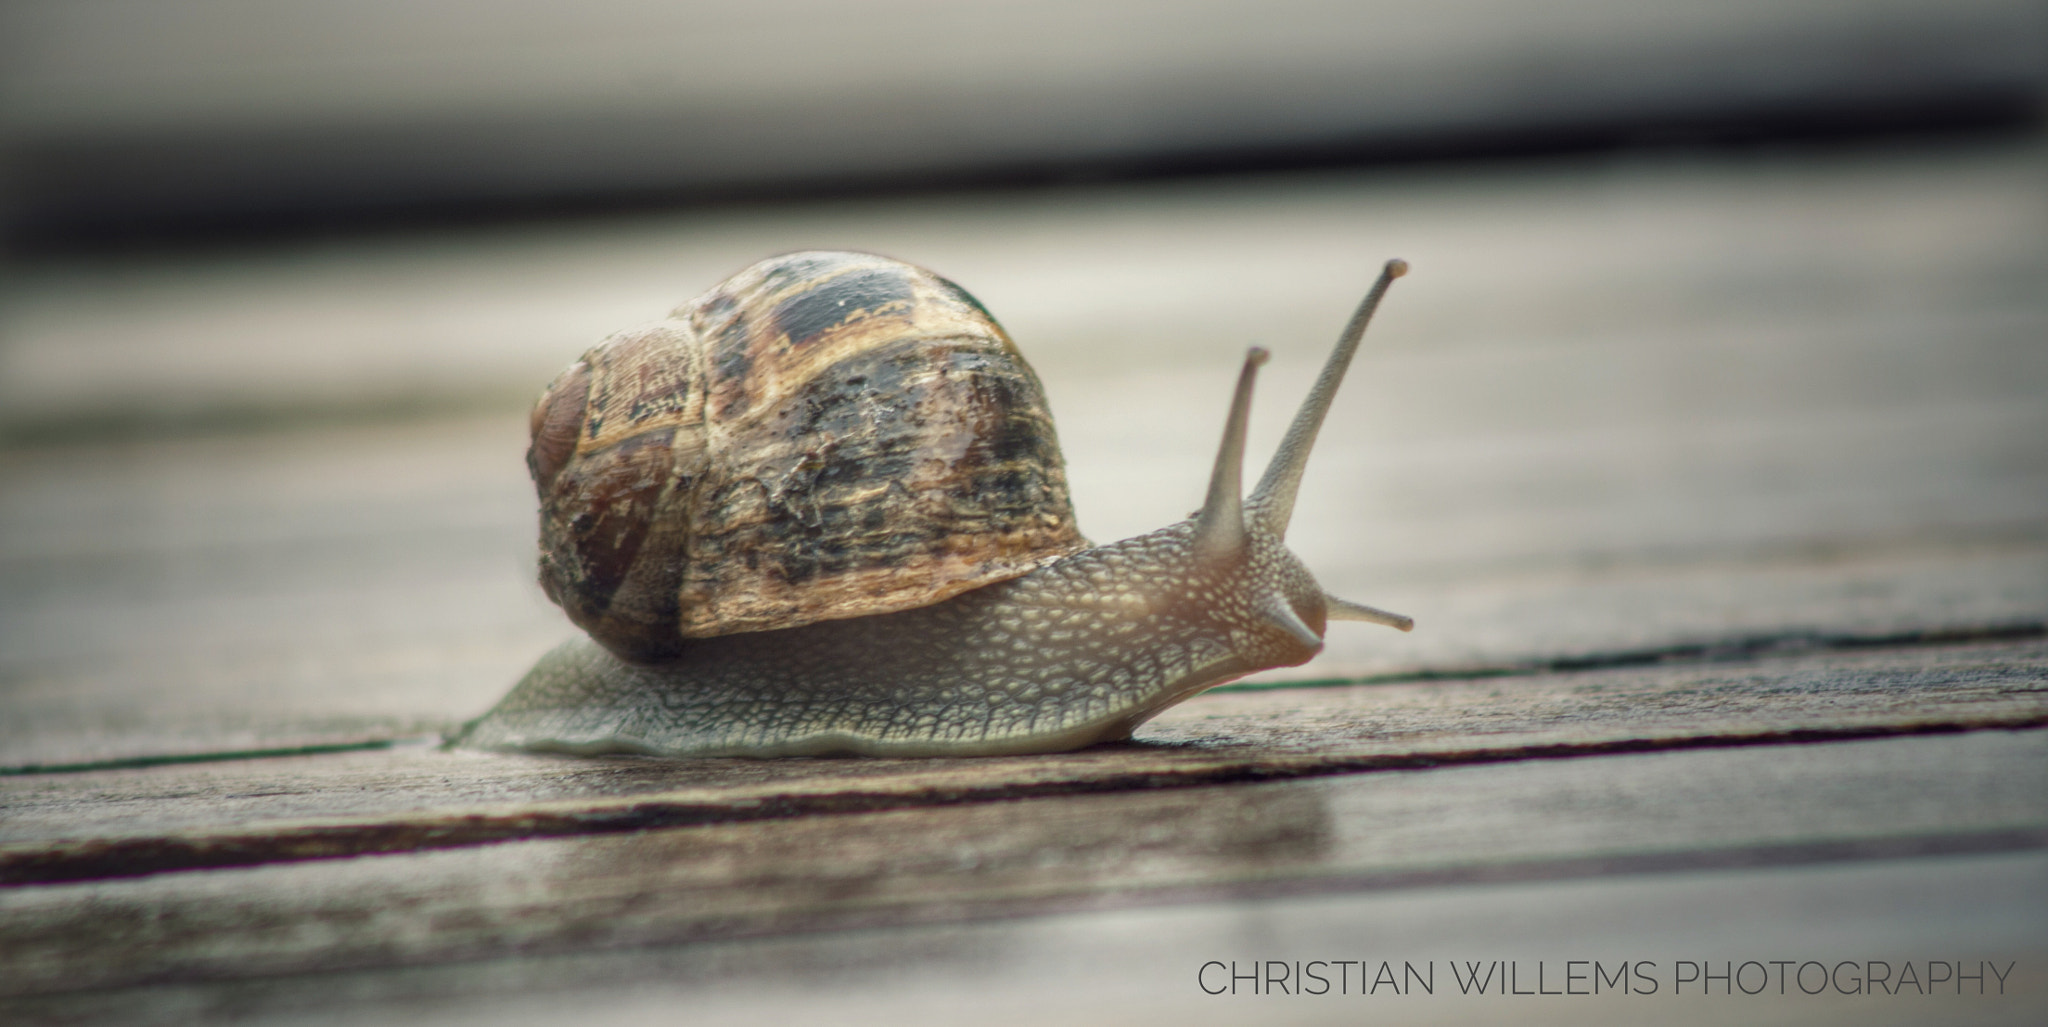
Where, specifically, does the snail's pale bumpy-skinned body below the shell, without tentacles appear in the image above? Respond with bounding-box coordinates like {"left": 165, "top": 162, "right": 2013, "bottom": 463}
{"left": 461, "top": 521, "right": 1325, "bottom": 756}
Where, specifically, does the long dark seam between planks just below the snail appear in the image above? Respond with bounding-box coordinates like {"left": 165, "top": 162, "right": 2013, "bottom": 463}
{"left": 0, "top": 713, "right": 2048, "bottom": 886}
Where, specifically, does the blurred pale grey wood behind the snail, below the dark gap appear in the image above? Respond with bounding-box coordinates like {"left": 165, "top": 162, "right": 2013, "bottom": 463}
{"left": 0, "top": 141, "right": 2048, "bottom": 765}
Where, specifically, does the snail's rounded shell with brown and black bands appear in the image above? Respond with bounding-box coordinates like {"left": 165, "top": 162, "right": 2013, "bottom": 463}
{"left": 526, "top": 252, "right": 1087, "bottom": 660}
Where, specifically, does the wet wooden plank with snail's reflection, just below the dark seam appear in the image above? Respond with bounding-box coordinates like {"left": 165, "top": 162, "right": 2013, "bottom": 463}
{"left": 0, "top": 732, "right": 2048, "bottom": 994}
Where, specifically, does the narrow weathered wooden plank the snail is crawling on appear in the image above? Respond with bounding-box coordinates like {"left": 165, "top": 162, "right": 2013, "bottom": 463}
{"left": 0, "top": 640, "right": 2048, "bottom": 881}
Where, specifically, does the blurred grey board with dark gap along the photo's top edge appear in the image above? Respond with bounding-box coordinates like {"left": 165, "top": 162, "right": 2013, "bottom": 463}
{"left": 0, "top": 0, "right": 2044, "bottom": 248}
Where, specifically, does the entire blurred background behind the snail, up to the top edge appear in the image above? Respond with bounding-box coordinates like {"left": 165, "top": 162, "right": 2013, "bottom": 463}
{"left": 0, "top": 0, "right": 2048, "bottom": 767}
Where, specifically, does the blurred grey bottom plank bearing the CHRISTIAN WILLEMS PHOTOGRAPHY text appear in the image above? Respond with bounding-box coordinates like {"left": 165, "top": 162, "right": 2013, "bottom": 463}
{"left": 0, "top": 853, "right": 2048, "bottom": 1027}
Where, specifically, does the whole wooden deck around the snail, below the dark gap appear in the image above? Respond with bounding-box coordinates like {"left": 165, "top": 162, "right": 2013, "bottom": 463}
{"left": 0, "top": 139, "right": 2048, "bottom": 1025}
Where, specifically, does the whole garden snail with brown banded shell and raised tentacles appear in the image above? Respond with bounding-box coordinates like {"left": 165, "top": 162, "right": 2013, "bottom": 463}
{"left": 455, "top": 252, "right": 1413, "bottom": 756}
